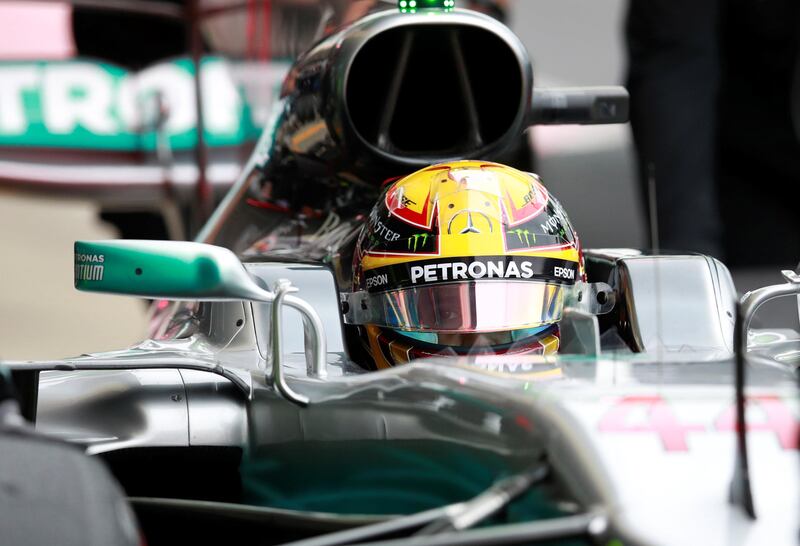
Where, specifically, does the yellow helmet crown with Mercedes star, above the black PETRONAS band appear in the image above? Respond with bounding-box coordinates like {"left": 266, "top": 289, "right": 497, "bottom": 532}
{"left": 356, "top": 161, "right": 579, "bottom": 271}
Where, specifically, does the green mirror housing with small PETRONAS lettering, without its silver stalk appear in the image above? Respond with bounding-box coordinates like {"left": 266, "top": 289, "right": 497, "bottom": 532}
{"left": 75, "top": 241, "right": 221, "bottom": 299}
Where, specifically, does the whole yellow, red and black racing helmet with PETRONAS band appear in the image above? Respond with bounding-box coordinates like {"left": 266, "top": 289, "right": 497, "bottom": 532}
{"left": 346, "top": 161, "right": 584, "bottom": 368}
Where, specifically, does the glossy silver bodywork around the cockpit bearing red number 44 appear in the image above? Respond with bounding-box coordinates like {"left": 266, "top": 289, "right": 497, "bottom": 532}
{"left": 17, "top": 251, "right": 800, "bottom": 544}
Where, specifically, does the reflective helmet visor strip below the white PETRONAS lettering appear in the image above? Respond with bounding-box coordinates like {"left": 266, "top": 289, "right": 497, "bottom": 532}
{"left": 368, "top": 280, "right": 567, "bottom": 333}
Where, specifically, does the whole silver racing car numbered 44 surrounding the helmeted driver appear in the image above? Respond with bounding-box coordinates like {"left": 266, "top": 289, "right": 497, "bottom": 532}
{"left": 4, "top": 0, "right": 800, "bottom": 546}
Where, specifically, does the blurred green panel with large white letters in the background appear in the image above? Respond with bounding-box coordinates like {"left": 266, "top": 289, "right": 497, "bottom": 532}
{"left": 0, "top": 57, "right": 260, "bottom": 152}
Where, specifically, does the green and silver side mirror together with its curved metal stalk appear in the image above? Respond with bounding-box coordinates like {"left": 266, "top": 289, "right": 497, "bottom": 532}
{"left": 75, "top": 240, "right": 327, "bottom": 405}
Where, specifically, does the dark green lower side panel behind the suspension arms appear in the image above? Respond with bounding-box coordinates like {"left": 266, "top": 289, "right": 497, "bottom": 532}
{"left": 240, "top": 440, "right": 565, "bottom": 523}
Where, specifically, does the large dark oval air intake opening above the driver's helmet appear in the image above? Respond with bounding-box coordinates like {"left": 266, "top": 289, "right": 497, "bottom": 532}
{"left": 345, "top": 24, "right": 527, "bottom": 159}
